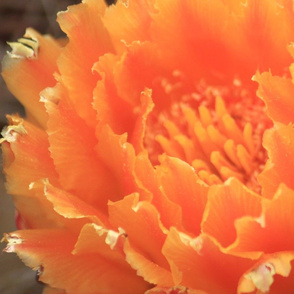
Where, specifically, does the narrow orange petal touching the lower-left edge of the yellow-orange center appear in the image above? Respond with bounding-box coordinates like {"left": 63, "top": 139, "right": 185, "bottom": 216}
{"left": 157, "top": 156, "right": 208, "bottom": 236}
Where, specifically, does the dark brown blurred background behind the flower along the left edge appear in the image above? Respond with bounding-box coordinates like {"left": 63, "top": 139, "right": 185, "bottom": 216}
{"left": 0, "top": 0, "right": 117, "bottom": 294}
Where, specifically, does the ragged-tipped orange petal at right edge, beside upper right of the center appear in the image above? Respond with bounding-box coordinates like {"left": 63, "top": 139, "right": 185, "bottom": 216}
{"left": 253, "top": 72, "right": 294, "bottom": 124}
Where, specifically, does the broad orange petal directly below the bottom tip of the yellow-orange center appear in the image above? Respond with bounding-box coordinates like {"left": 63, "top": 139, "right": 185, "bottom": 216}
{"left": 201, "top": 178, "right": 262, "bottom": 247}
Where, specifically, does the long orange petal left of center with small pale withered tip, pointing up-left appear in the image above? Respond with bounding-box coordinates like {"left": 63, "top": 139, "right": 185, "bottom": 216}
{"left": 42, "top": 84, "right": 117, "bottom": 212}
